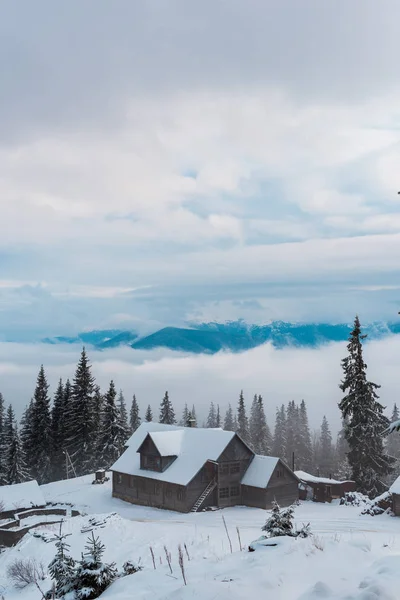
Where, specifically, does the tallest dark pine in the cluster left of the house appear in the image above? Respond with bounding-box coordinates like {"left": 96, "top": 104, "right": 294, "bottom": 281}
{"left": 66, "top": 348, "right": 97, "bottom": 475}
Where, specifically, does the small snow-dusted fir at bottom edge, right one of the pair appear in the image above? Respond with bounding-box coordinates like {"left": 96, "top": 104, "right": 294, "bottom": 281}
{"left": 72, "top": 532, "right": 117, "bottom": 600}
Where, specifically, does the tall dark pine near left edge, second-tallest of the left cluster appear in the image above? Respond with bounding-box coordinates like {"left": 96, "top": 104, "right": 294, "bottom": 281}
{"left": 26, "top": 365, "right": 52, "bottom": 484}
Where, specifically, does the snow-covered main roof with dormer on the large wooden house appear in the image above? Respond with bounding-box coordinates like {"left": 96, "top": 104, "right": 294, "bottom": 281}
{"left": 111, "top": 422, "right": 235, "bottom": 485}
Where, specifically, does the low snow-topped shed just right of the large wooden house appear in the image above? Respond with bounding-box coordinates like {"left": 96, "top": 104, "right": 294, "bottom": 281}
{"left": 295, "top": 471, "right": 356, "bottom": 502}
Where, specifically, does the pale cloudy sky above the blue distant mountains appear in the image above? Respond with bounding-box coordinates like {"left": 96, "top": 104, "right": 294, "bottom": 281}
{"left": 0, "top": 0, "right": 400, "bottom": 337}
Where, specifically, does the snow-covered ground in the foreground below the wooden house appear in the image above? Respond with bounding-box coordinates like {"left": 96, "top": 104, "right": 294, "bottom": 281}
{"left": 0, "top": 477, "right": 400, "bottom": 600}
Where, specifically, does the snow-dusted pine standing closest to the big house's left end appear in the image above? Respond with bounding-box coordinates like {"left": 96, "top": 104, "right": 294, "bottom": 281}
{"left": 97, "top": 380, "right": 126, "bottom": 469}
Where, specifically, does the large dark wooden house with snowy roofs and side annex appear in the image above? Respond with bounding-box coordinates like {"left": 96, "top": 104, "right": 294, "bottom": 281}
{"left": 111, "top": 422, "right": 298, "bottom": 512}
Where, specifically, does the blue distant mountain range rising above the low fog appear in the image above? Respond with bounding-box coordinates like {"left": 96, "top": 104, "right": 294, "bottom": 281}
{"left": 42, "top": 321, "right": 400, "bottom": 354}
